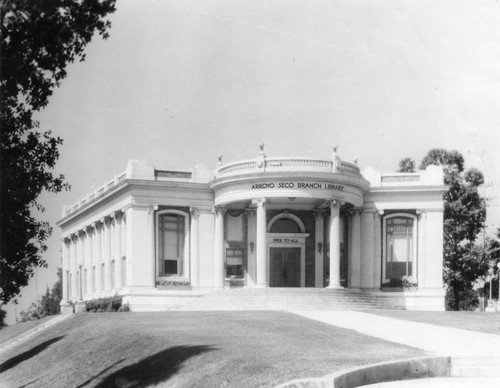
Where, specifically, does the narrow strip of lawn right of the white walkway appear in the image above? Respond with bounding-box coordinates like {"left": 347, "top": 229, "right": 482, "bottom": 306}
{"left": 370, "top": 310, "right": 500, "bottom": 335}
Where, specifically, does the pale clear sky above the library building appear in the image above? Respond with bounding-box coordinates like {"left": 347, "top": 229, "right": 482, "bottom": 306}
{"left": 4, "top": 0, "right": 500, "bottom": 322}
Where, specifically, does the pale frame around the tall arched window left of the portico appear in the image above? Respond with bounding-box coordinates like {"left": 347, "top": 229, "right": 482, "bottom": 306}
{"left": 155, "top": 209, "right": 191, "bottom": 278}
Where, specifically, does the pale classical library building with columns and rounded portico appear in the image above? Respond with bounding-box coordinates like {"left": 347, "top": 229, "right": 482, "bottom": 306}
{"left": 58, "top": 145, "right": 447, "bottom": 311}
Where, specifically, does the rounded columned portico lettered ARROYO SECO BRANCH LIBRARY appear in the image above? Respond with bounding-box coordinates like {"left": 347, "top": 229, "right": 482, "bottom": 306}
{"left": 211, "top": 148, "right": 368, "bottom": 288}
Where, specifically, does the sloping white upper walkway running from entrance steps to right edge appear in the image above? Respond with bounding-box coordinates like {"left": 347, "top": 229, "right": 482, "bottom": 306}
{"left": 293, "top": 311, "right": 500, "bottom": 358}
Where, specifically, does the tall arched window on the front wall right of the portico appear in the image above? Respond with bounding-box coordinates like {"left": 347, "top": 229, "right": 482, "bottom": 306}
{"left": 384, "top": 213, "right": 417, "bottom": 282}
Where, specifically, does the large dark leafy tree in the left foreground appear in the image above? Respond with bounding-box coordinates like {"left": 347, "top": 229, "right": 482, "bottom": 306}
{"left": 0, "top": 0, "right": 115, "bottom": 303}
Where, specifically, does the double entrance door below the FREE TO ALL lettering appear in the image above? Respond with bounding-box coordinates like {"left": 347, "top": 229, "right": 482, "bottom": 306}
{"left": 269, "top": 248, "right": 300, "bottom": 287}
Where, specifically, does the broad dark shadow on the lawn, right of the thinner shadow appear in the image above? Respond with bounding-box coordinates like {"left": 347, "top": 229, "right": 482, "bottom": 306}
{"left": 96, "top": 345, "right": 215, "bottom": 388}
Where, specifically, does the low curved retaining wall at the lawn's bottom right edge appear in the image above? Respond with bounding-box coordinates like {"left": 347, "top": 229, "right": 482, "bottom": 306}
{"left": 275, "top": 357, "right": 451, "bottom": 388}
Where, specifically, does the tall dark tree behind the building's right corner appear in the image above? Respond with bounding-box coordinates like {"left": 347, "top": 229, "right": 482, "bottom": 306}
{"left": 420, "top": 149, "right": 488, "bottom": 310}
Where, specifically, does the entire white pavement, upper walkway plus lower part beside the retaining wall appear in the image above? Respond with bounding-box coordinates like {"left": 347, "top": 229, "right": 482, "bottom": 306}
{"left": 292, "top": 311, "right": 500, "bottom": 388}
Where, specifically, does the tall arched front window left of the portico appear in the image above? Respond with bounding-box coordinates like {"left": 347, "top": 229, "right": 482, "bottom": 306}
{"left": 157, "top": 210, "right": 189, "bottom": 276}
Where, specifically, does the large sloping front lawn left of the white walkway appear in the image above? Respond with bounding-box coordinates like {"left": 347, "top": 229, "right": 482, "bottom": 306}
{"left": 0, "top": 311, "right": 425, "bottom": 387}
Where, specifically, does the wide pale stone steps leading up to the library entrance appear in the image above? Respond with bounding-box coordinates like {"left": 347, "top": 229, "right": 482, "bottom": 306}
{"left": 176, "top": 288, "right": 401, "bottom": 311}
